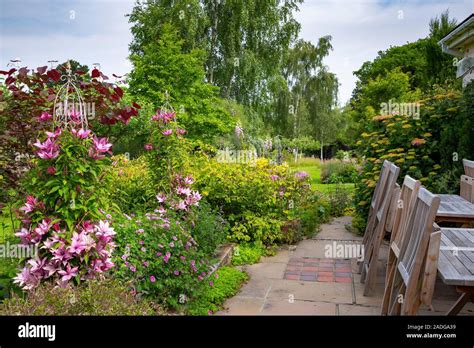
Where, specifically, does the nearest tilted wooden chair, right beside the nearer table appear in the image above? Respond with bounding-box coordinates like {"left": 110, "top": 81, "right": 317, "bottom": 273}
{"left": 382, "top": 187, "right": 441, "bottom": 315}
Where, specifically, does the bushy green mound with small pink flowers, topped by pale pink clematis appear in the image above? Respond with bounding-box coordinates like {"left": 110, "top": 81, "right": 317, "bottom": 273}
{"left": 115, "top": 175, "right": 219, "bottom": 308}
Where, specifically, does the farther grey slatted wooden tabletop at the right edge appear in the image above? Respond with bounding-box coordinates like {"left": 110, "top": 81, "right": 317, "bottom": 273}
{"left": 436, "top": 195, "right": 474, "bottom": 224}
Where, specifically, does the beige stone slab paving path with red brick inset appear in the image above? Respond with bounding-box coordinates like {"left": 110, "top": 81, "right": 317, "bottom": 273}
{"left": 217, "top": 217, "right": 474, "bottom": 315}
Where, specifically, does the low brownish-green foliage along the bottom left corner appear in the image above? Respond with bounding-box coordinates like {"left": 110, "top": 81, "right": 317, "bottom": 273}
{"left": 0, "top": 279, "right": 159, "bottom": 316}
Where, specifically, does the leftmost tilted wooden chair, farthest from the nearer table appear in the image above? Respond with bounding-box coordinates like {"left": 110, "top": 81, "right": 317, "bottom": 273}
{"left": 359, "top": 161, "right": 400, "bottom": 296}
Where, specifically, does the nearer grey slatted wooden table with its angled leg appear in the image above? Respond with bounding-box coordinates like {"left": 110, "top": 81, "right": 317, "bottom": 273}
{"left": 438, "top": 228, "right": 474, "bottom": 315}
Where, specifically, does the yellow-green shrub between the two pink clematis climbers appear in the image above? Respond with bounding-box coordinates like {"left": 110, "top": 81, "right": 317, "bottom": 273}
{"left": 109, "top": 155, "right": 156, "bottom": 213}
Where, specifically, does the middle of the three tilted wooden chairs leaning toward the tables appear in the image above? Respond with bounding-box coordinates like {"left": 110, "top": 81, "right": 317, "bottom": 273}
{"left": 382, "top": 175, "right": 421, "bottom": 315}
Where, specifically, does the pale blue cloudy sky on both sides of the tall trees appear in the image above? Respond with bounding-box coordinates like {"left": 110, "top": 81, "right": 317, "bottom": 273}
{"left": 0, "top": 0, "right": 474, "bottom": 104}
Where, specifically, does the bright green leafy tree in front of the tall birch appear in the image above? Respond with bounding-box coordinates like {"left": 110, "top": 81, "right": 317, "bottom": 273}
{"left": 129, "top": 24, "right": 234, "bottom": 142}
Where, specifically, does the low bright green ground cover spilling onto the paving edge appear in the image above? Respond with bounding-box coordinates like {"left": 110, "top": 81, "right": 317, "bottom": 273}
{"left": 187, "top": 266, "right": 248, "bottom": 315}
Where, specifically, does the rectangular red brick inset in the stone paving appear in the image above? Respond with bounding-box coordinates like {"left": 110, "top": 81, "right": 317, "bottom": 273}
{"left": 283, "top": 257, "right": 352, "bottom": 283}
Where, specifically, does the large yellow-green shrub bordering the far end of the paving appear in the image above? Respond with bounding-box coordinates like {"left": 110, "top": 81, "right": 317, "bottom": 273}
{"left": 194, "top": 159, "right": 323, "bottom": 245}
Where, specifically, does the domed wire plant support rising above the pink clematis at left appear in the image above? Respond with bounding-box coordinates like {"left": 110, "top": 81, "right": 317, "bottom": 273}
{"left": 53, "top": 61, "right": 88, "bottom": 129}
